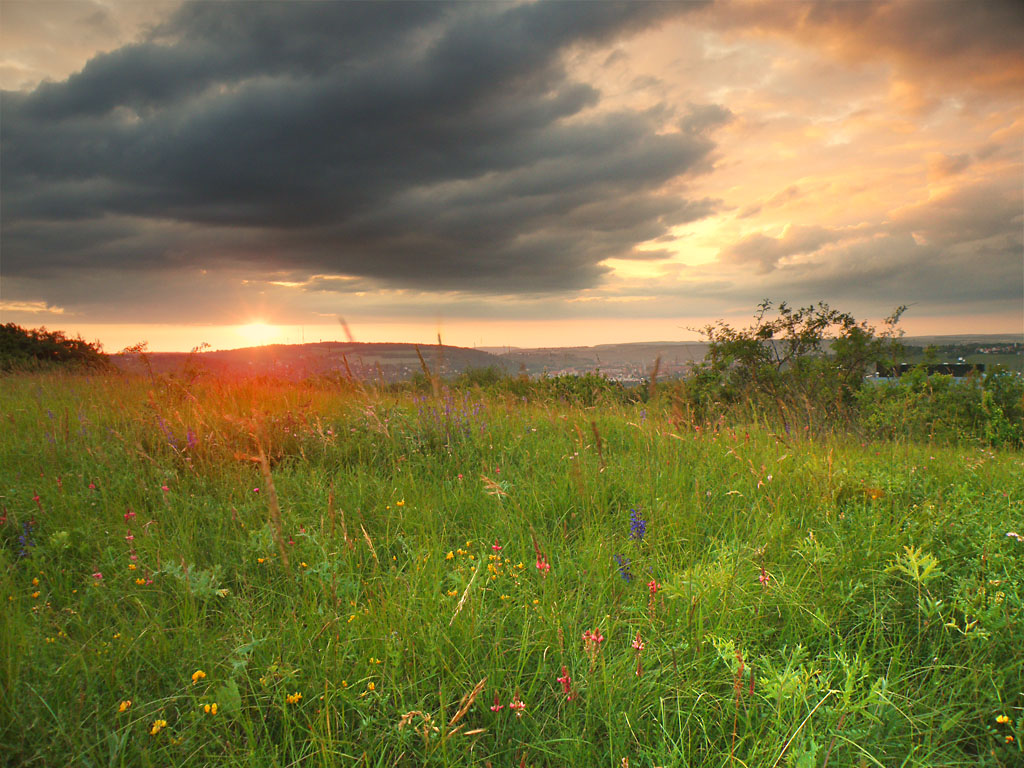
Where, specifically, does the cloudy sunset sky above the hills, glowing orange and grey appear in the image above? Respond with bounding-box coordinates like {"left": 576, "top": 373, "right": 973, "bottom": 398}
{"left": 0, "top": 0, "right": 1024, "bottom": 351}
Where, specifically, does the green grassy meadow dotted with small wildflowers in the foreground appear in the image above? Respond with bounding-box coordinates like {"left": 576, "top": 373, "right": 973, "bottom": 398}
{"left": 0, "top": 374, "right": 1024, "bottom": 768}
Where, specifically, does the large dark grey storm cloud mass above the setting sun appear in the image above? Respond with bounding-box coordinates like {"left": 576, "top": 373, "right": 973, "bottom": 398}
{"left": 0, "top": 2, "right": 731, "bottom": 292}
